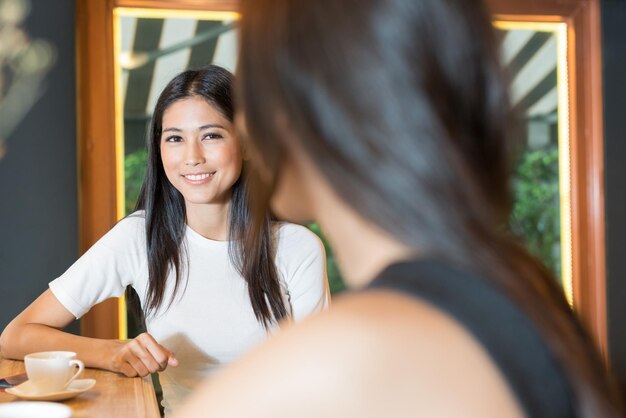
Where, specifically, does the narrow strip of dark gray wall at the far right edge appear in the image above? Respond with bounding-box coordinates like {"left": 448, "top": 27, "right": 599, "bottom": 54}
{"left": 601, "top": 0, "right": 626, "bottom": 389}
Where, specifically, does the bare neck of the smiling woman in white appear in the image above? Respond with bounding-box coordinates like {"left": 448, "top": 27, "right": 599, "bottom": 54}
{"left": 187, "top": 202, "right": 230, "bottom": 241}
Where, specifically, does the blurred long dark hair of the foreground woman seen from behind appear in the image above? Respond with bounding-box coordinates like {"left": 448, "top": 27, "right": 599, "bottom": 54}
{"left": 237, "top": 0, "right": 619, "bottom": 418}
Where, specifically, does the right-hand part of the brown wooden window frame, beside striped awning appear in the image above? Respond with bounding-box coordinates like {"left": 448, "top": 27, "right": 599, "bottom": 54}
{"left": 487, "top": 0, "right": 607, "bottom": 359}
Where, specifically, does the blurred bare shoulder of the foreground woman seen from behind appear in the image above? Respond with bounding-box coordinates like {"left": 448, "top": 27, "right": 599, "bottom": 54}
{"left": 173, "top": 291, "right": 523, "bottom": 418}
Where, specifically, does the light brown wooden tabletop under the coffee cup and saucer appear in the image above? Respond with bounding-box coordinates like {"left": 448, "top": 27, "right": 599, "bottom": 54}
{"left": 0, "top": 357, "right": 160, "bottom": 418}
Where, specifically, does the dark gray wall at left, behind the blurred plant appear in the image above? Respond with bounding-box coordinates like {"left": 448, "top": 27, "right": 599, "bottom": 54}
{"left": 0, "top": 0, "right": 78, "bottom": 332}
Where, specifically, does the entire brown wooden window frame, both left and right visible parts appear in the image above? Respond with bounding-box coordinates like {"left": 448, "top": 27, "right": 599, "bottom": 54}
{"left": 76, "top": 0, "right": 607, "bottom": 356}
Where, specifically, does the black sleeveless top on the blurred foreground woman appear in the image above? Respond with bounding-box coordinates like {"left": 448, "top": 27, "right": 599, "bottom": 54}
{"left": 368, "top": 261, "right": 577, "bottom": 418}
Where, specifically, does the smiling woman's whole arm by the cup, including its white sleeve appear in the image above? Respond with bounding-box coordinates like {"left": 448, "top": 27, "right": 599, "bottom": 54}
{"left": 0, "top": 216, "right": 176, "bottom": 376}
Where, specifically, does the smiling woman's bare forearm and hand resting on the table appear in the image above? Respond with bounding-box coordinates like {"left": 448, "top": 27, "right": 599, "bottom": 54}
{"left": 0, "top": 290, "right": 177, "bottom": 376}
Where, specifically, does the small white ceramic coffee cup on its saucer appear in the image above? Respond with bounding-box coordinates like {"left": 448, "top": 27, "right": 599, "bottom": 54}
{"left": 24, "top": 351, "right": 85, "bottom": 394}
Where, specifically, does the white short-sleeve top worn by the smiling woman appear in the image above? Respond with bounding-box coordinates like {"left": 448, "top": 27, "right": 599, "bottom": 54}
{"left": 50, "top": 212, "right": 329, "bottom": 413}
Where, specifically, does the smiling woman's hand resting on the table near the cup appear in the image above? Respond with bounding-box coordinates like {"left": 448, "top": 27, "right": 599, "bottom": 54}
{"left": 111, "top": 332, "right": 178, "bottom": 377}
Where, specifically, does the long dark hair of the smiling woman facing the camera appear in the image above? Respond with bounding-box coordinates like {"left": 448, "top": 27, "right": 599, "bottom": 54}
{"left": 127, "top": 65, "right": 287, "bottom": 327}
